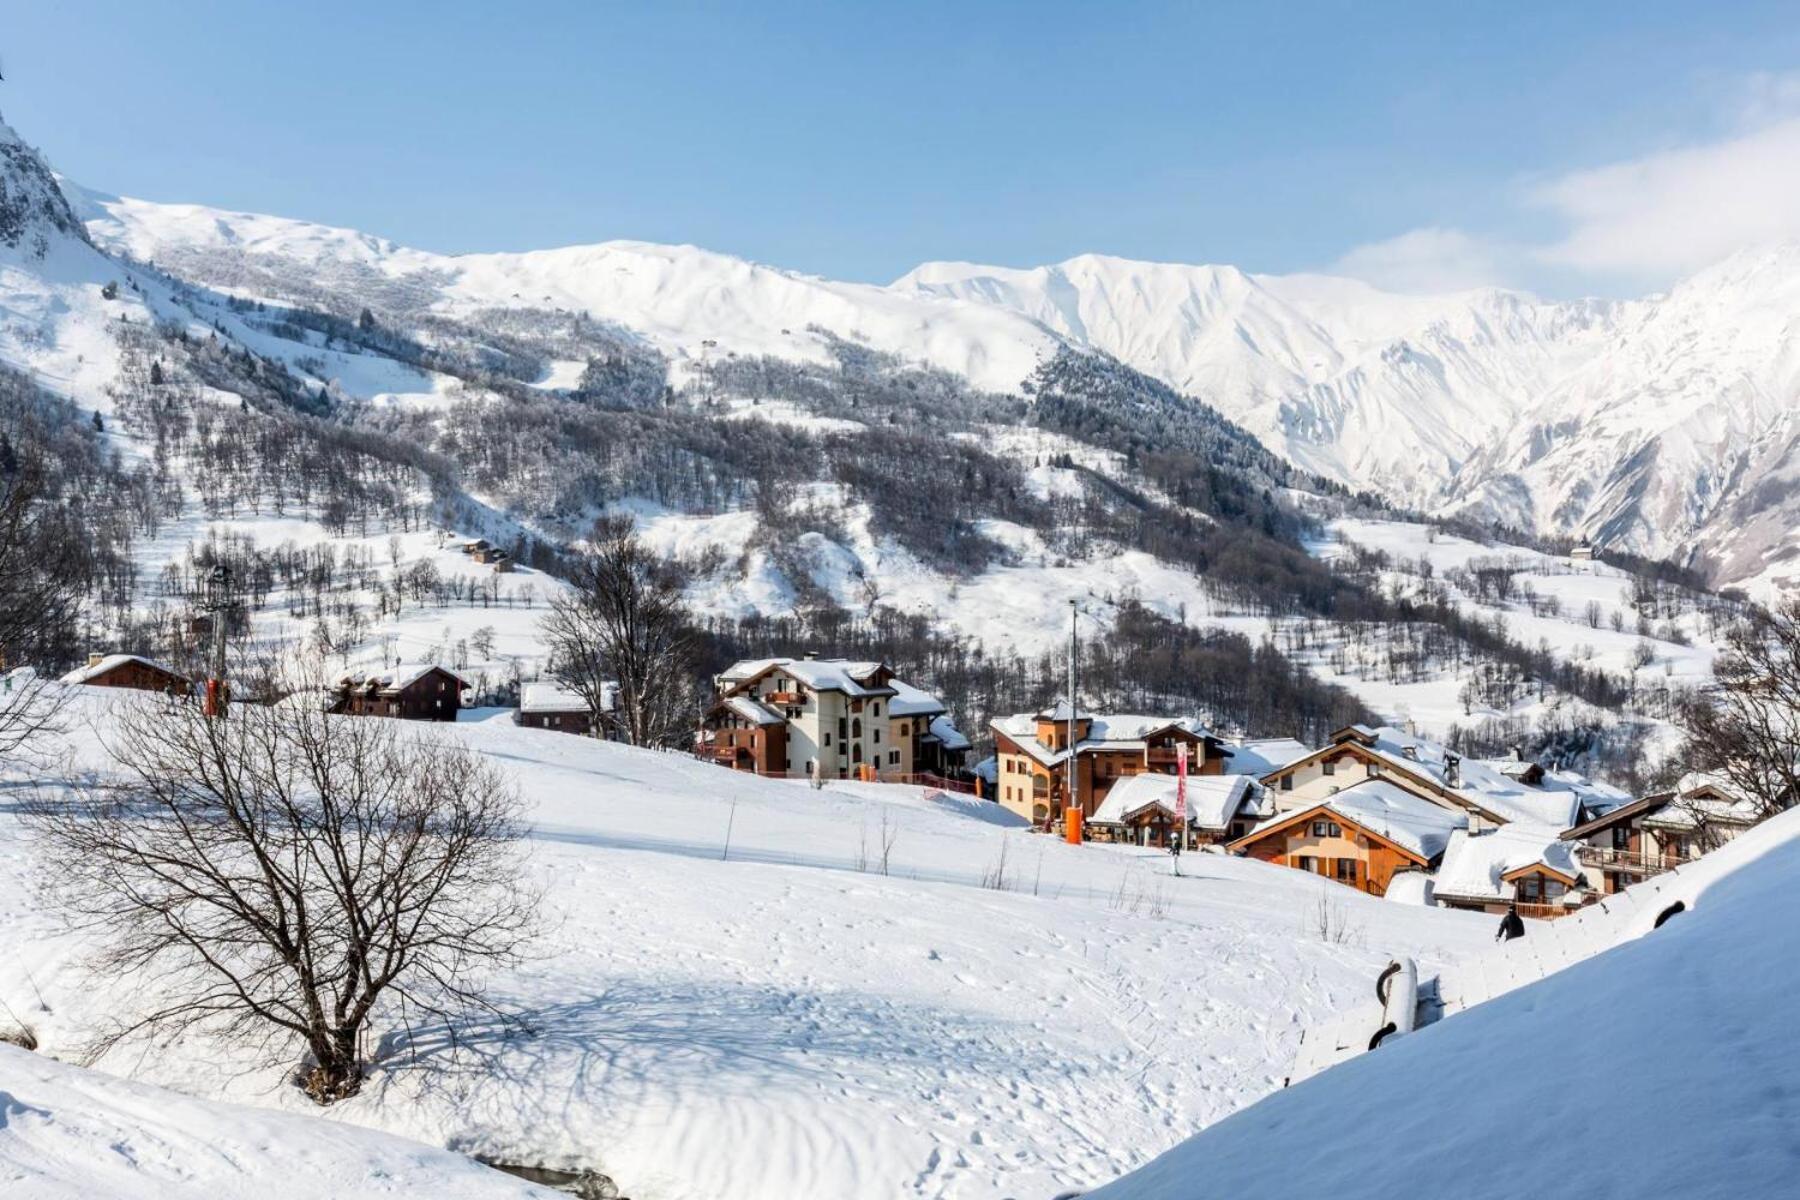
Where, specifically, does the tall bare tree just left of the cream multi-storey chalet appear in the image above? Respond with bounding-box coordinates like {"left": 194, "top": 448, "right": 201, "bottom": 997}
{"left": 540, "top": 518, "right": 698, "bottom": 747}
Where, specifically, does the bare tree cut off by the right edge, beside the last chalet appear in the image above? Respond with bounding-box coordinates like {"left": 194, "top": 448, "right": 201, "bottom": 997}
{"left": 1685, "top": 597, "right": 1800, "bottom": 817}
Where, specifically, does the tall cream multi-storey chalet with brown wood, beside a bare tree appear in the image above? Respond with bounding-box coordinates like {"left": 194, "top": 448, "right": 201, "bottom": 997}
{"left": 698, "top": 658, "right": 970, "bottom": 779}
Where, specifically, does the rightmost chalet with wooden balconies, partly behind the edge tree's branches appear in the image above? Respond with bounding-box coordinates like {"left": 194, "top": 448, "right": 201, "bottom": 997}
{"left": 1562, "top": 779, "right": 1766, "bottom": 896}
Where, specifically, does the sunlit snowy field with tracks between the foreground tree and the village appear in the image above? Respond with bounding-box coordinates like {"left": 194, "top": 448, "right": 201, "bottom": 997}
{"left": 0, "top": 691, "right": 1490, "bottom": 1200}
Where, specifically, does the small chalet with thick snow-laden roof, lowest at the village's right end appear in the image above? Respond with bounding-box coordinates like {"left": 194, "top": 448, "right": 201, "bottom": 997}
{"left": 1431, "top": 824, "right": 1593, "bottom": 918}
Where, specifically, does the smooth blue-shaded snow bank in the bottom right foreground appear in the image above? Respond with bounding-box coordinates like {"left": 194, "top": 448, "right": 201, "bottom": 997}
{"left": 1091, "top": 813, "right": 1800, "bottom": 1200}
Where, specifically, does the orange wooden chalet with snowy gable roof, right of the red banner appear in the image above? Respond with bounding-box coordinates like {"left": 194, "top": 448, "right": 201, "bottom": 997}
{"left": 1228, "top": 777, "right": 1467, "bottom": 896}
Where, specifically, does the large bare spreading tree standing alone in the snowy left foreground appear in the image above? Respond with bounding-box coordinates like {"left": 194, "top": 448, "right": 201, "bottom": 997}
{"left": 25, "top": 690, "right": 536, "bottom": 1103}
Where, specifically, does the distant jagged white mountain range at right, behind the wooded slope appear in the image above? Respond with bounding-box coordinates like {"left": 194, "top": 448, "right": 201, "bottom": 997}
{"left": 895, "top": 246, "right": 1800, "bottom": 583}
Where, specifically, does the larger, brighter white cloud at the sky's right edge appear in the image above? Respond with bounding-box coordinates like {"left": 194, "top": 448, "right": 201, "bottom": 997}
{"left": 1530, "top": 117, "right": 1800, "bottom": 282}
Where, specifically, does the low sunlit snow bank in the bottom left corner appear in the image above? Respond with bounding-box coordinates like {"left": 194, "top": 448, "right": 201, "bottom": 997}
{"left": 0, "top": 1045, "right": 554, "bottom": 1200}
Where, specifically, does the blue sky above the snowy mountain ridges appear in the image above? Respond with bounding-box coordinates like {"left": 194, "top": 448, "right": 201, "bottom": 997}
{"left": 10, "top": 0, "right": 1800, "bottom": 291}
